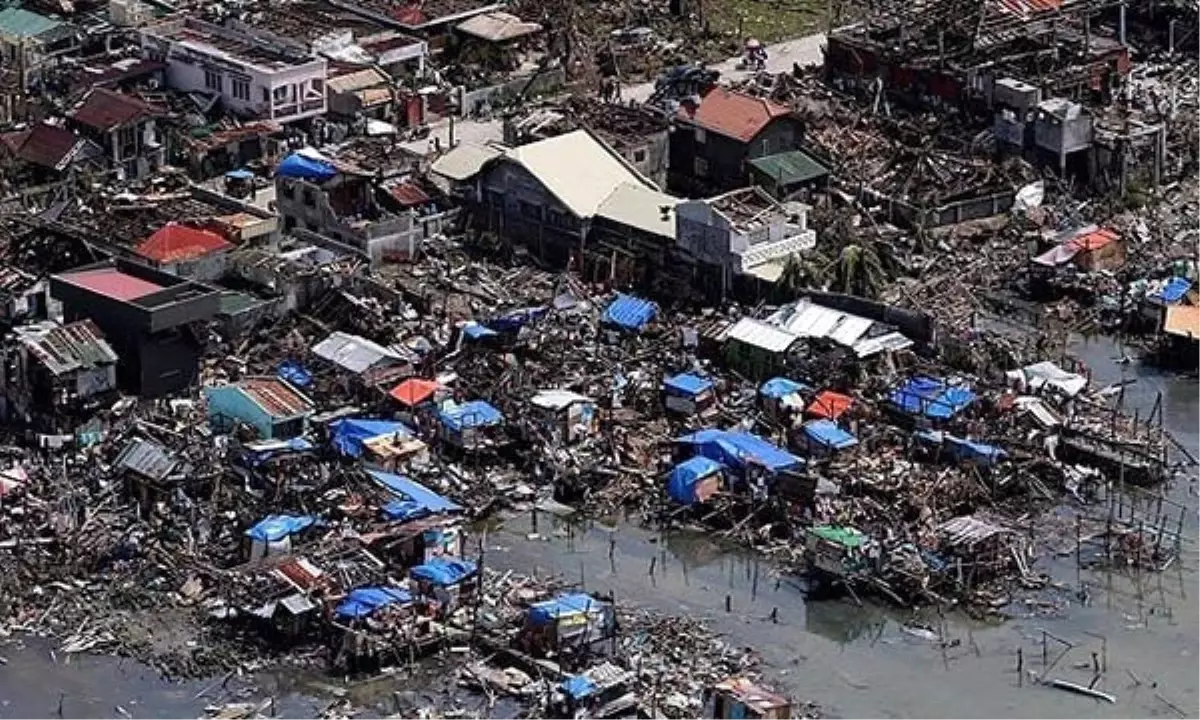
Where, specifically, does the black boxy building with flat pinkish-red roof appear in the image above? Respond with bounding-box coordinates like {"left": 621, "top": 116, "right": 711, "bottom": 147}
{"left": 50, "top": 260, "right": 220, "bottom": 397}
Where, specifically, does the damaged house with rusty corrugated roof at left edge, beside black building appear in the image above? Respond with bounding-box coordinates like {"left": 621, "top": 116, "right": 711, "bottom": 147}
{"left": 0, "top": 320, "right": 118, "bottom": 430}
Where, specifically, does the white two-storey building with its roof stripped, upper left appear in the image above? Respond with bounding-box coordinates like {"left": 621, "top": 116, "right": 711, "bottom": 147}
{"left": 142, "top": 18, "right": 326, "bottom": 122}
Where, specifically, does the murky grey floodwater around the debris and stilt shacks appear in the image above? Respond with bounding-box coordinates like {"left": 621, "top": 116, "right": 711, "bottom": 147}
{"left": 0, "top": 333, "right": 1200, "bottom": 720}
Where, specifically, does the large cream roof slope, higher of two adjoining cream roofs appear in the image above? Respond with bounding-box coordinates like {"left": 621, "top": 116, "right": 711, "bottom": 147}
{"left": 504, "top": 130, "right": 644, "bottom": 218}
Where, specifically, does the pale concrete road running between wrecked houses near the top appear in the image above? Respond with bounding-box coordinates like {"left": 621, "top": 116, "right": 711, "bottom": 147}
{"left": 401, "top": 32, "right": 826, "bottom": 155}
